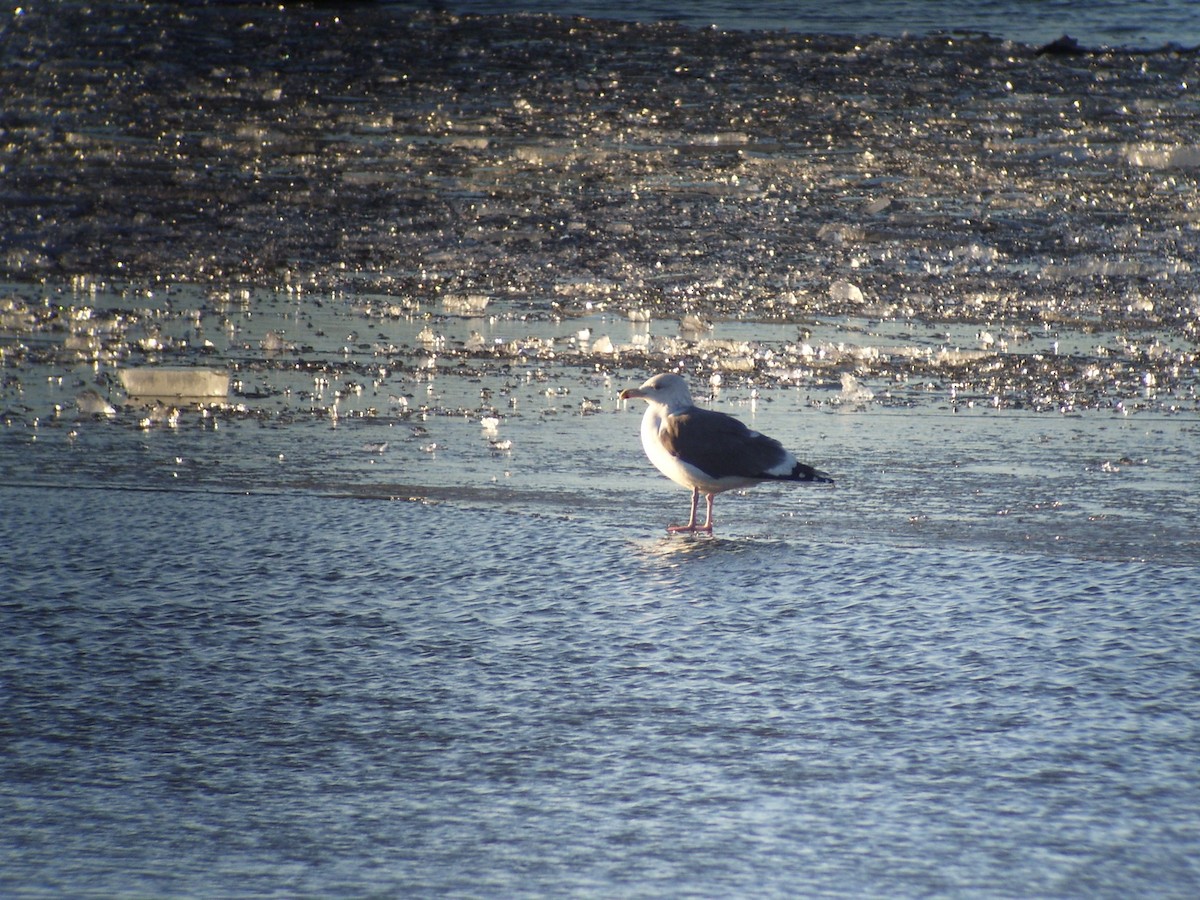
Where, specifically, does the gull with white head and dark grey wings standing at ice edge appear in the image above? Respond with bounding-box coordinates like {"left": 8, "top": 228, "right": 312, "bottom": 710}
{"left": 620, "top": 372, "right": 833, "bottom": 534}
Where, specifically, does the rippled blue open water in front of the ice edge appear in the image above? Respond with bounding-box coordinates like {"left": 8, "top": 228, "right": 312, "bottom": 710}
{"left": 0, "top": 488, "right": 1200, "bottom": 898}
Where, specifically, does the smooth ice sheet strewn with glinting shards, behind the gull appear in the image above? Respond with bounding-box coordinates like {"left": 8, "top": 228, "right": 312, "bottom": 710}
{"left": 0, "top": 278, "right": 1200, "bottom": 563}
